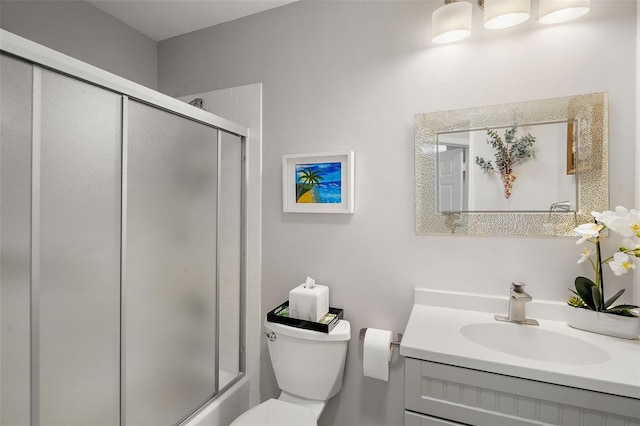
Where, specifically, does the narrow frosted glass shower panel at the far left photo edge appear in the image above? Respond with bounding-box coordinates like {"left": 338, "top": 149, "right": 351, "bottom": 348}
{"left": 0, "top": 55, "right": 33, "bottom": 425}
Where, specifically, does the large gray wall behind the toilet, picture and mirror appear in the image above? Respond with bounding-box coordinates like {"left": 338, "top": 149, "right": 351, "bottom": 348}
{"left": 158, "top": 0, "right": 636, "bottom": 426}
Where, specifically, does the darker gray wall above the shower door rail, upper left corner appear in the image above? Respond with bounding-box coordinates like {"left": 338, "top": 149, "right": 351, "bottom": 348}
{"left": 0, "top": 0, "right": 158, "bottom": 89}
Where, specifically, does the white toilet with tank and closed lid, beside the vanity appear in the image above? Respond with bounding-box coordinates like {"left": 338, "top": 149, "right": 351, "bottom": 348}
{"left": 231, "top": 320, "right": 351, "bottom": 426}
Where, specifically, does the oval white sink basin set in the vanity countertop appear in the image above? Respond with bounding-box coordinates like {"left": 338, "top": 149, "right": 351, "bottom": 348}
{"left": 460, "top": 322, "right": 609, "bottom": 365}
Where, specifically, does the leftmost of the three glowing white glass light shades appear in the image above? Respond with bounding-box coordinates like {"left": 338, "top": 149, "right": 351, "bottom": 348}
{"left": 431, "top": 1, "right": 472, "bottom": 44}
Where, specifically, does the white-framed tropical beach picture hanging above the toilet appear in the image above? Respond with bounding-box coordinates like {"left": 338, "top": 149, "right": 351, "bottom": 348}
{"left": 282, "top": 151, "right": 354, "bottom": 213}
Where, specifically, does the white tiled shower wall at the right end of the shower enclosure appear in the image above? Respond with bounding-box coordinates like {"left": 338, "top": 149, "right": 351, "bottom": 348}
{"left": 180, "top": 84, "right": 262, "bottom": 406}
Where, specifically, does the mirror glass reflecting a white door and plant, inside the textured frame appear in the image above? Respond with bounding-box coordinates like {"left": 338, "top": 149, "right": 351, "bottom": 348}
{"left": 436, "top": 120, "right": 577, "bottom": 212}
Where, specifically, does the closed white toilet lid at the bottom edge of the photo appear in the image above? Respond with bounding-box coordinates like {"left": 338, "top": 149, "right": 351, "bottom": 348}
{"left": 231, "top": 399, "right": 318, "bottom": 426}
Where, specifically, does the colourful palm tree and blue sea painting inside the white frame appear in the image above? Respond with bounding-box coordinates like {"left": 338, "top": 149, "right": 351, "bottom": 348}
{"left": 296, "top": 161, "right": 342, "bottom": 204}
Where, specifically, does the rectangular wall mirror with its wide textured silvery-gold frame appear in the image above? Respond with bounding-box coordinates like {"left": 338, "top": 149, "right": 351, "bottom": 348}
{"left": 415, "top": 93, "right": 609, "bottom": 236}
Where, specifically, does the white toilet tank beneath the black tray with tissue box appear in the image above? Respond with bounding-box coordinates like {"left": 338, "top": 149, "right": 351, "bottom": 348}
{"left": 264, "top": 320, "right": 351, "bottom": 401}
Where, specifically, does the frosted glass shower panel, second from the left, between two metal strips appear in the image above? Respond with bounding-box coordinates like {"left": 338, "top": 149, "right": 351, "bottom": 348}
{"left": 39, "top": 70, "right": 122, "bottom": 426}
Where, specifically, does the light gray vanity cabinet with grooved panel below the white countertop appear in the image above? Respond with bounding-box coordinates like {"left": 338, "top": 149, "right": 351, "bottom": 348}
{"left": 404, "top": 358, "right": 640, "bottom": 426}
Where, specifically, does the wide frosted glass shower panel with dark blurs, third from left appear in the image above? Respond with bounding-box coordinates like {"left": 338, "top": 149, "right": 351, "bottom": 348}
{"left": 123, "top": 101, "right": 218, "bottom": 425}
